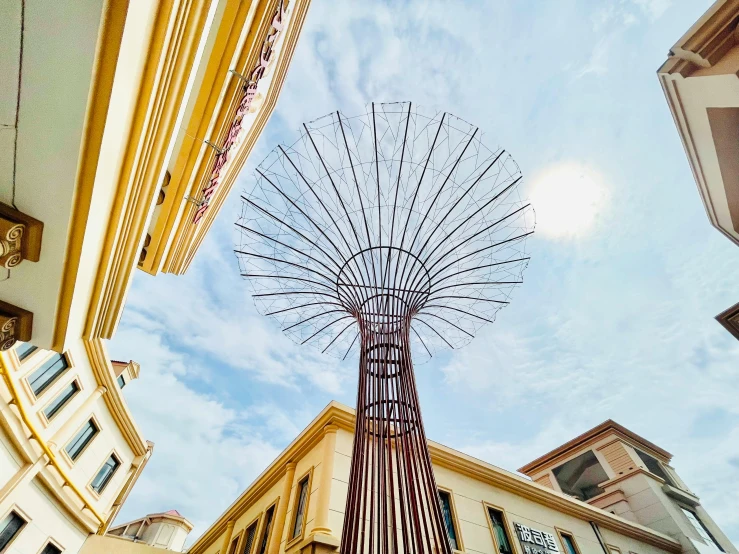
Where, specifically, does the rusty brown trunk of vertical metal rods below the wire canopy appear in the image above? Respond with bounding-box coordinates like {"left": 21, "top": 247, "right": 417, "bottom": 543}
{"left": 341, "top": 316, "right": 451, "bottom": 554}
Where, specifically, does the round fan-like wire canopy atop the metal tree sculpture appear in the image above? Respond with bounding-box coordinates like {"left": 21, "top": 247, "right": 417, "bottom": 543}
{"left": 236, "top": 103, "right": 533, "bottom": 359}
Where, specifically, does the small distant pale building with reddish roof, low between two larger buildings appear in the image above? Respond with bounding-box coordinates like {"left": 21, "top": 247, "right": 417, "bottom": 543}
{"left": 108, "top": 510, "right": 192, "bottom": 552}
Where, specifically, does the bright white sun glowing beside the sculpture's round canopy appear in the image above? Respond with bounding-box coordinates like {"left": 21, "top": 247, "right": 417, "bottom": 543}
{"left": 530, "top": 162, "right": 608, "bottom": 239}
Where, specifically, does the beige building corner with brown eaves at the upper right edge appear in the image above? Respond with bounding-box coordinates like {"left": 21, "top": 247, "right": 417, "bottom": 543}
{"left": 657, "top": 0, "right": 739, "bottom": 339}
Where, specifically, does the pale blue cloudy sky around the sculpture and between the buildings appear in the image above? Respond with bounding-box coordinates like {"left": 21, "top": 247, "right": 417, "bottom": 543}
{"left": 110, "top": 0, "right": 739, "bottom": 544}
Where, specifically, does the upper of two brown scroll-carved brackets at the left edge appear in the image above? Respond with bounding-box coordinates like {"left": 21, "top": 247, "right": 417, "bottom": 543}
{"left": 0, "top": 202, "right": 44, "bottom": 269}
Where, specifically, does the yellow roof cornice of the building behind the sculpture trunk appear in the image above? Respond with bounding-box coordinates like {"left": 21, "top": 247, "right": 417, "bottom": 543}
{"left": 188, "top": 402, "right": 681, "bottom": 554}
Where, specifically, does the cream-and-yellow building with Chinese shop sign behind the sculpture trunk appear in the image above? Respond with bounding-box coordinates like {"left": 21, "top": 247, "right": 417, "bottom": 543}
{"left": 188, "top": 402, "right": 737, "bottom": 554}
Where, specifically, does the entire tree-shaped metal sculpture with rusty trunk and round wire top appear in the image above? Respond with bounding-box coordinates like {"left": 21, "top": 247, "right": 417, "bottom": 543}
{"left": 236, "top": 103, "right": 533, "bottom": 554}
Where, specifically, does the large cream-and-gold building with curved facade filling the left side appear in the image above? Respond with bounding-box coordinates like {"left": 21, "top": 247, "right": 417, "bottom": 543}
{"left": 0, "top": 0, "right": 309, "bottom": 554}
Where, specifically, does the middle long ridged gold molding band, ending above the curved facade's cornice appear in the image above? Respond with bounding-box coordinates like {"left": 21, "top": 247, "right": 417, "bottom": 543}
{"left": 84, "top": 0, "right": 217, "bottom": 340}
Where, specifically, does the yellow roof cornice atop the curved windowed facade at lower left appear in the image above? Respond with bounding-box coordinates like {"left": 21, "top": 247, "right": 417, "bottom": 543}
{"left": 82, "top": 339, "right": 148, "bottom": 456}
